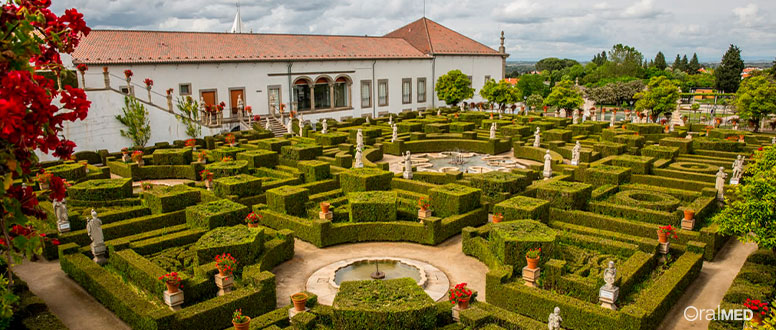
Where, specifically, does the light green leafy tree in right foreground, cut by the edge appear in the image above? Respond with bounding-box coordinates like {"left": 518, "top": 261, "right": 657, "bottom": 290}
{"left": 712, "top": 146, "right": 776, "bottom": 251}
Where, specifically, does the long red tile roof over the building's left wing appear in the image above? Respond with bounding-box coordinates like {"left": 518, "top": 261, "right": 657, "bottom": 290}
{"left": 73, "top": 30, "right": 429, "bottom": 64}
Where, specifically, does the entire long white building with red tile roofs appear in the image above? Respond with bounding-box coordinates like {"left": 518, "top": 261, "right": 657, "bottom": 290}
{"left": 65, "top": 18, "right": 508, "bottom": 150}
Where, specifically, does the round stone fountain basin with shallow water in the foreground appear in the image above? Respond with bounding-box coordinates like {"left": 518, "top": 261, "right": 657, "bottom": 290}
{"left": 305, "top": 257, "right": 450, "bottom": 305}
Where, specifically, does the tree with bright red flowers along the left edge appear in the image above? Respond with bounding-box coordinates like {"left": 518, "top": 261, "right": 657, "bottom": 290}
{"left": 0, "top": 1, "right": 91, "bottom": 296}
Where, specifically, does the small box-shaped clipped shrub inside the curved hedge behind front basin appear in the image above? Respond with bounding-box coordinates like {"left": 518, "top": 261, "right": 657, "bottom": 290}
{"left": 348, "top": 191, "right": 396, "bottom": 222}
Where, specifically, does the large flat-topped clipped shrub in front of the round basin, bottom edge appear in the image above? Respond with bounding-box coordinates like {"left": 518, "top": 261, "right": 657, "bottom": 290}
{"left": 332, "top": 278, "right": 436, "bottom": 330}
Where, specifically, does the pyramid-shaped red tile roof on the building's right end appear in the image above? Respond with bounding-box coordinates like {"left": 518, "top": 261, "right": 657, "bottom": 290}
{"left": 385, "top": 17, "right": 502, "bottom": 56}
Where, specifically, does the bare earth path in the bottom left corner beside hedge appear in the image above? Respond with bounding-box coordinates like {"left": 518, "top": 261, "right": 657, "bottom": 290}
{"left": 14, "top": 260, "right": 131, "bottom": 330}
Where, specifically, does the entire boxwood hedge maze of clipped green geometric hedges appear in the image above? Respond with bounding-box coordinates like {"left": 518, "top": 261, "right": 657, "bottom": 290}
{"left": 28, "top": 108, "right": 776, "bottom": 329}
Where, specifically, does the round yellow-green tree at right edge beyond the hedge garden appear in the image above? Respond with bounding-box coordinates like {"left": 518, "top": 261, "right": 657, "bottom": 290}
{"left": 733, "top": 74, "right": 776, "bottom": 132}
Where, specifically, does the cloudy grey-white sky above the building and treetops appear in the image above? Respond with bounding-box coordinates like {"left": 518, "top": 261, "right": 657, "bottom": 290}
{"left": 52, "top": 0, "right": 776, "bottom": 62}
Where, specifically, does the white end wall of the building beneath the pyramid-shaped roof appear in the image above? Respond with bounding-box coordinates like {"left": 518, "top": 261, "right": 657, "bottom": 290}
{"left": 434, "top": 55, "right": 501, "bottom": 106}
